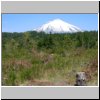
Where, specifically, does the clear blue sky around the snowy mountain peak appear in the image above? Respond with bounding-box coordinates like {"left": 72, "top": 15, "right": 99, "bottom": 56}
{"left": 2, "top": 14, "right": 98, "bottom": 32}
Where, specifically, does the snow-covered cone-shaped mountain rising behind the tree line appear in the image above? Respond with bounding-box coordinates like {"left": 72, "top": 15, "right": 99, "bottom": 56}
{"left": 35, "top": 19, "right": 82, "bottom": 33}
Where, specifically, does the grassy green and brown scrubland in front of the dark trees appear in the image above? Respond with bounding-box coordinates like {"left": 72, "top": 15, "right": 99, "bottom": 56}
{"left": 2, "top": 49, "right": 98, "bottom": 85}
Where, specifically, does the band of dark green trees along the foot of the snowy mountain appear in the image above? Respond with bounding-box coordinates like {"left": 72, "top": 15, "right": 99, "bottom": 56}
{"left": 2, "top": 31, "right": 98, "bottom": 52}
